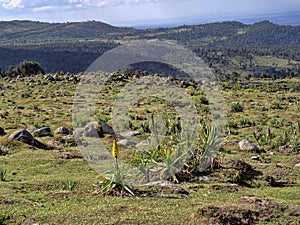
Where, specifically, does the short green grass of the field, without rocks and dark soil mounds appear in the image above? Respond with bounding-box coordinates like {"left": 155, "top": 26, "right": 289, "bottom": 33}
{"left": 0, "top": 74, "right": 300, "bottom": 224}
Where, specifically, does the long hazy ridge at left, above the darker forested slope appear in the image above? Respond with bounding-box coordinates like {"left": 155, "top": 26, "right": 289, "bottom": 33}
{"left": 0, "top": 21, "right": 132, "bottom": 43}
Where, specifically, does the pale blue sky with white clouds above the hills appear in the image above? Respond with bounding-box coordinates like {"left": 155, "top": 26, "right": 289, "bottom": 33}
{"left": 0, "top": 0, "right": 300, "bottom": 25}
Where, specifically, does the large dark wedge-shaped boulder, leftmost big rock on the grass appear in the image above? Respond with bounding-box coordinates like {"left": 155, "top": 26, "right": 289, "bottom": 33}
{"left": 8, "top": 129, "right": 49, "bottom": 150}
